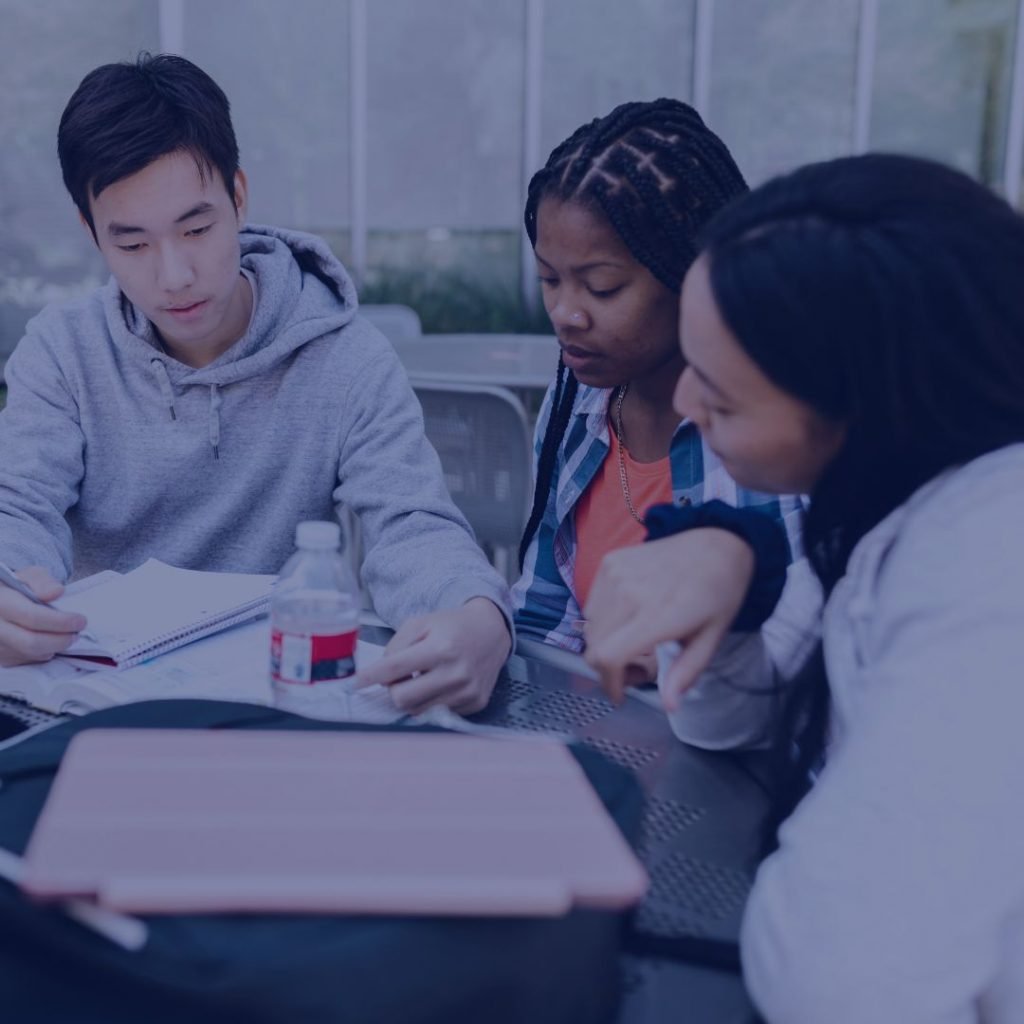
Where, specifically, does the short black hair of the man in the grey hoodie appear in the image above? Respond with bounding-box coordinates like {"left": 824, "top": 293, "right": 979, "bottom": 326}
{"left": 57, "top": 53, "right": 239, "bottom": 237}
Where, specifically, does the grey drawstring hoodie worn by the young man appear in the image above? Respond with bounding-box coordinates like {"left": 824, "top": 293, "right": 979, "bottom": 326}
{"left": 0, "top": 225, "right": 509, "bottom": 624}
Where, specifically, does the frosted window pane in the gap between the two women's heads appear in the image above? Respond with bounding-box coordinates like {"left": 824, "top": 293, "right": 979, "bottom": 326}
{"left": 709, "top": 0, "right": 864, "bottom": 185}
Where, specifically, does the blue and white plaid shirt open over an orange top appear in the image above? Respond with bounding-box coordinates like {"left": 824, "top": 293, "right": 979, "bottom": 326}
{"left": 512, "top": 384, "right": 802, "bottom": 652}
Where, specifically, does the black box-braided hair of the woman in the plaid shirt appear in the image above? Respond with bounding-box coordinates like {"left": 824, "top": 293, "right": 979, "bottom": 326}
{"left": 519, "top": 99, "right": 748, "bottom": 569}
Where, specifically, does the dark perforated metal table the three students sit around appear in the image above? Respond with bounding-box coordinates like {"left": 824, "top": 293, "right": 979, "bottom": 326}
{"left": 0, "top": 626, "right": 766, "bottom": 1024}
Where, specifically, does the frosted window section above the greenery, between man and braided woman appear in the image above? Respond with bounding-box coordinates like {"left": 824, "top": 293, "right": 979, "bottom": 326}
{"left": 367, "top": 0, "right": 525, "bottom": 230}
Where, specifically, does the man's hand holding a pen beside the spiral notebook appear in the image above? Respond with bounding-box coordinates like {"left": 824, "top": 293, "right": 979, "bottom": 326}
{"left": 0, "top": 565, "right": 85, "bottom": 668}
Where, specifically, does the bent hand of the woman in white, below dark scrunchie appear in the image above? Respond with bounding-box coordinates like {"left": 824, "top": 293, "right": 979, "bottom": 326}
{"left": 584, "top": 527, "right": 754, "bottom": 709}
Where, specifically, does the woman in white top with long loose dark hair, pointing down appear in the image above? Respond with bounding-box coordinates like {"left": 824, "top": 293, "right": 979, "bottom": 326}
{"left": 586, "top": 156, "right": 1024, "bottom": 1024}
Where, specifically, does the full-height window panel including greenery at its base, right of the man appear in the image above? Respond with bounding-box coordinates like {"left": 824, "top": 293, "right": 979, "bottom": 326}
{"left": 360, "top": 0, "right": 525, "bottom": 331}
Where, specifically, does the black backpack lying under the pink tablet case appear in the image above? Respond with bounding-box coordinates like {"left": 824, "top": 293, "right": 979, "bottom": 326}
{"left": 0, "top": 700, "right": 642, "bottom": 1024}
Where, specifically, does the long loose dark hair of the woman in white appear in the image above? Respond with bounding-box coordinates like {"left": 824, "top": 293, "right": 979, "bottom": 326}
{"left": 705, "top": 155, "right": 1024, "bottom": 836}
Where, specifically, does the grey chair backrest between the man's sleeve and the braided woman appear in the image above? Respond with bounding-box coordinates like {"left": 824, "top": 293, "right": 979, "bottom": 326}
{"left": 413, "top": 377, "right": 532, "bottom": 577}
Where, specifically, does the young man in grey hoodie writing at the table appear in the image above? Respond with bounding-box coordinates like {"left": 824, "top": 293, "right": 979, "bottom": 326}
{"left": 0, "top": 54, "right": 511, "bottom": 712}
